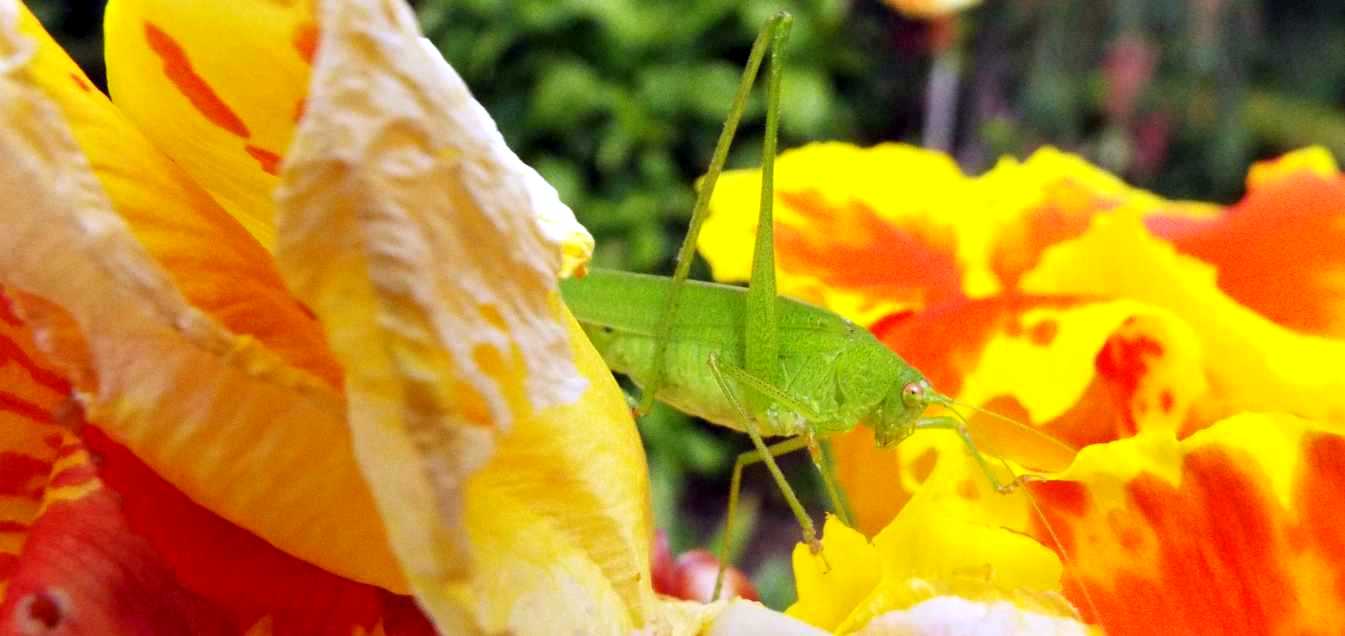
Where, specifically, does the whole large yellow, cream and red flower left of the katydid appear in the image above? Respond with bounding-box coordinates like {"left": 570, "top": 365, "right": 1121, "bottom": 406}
{"left": 0, "top": 0, "right": 784, "bottom": 633}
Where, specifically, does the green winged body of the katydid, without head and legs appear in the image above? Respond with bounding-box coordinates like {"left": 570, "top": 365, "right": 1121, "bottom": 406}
{"left": 561, "top": 270, "right": 921, "bottom": 436}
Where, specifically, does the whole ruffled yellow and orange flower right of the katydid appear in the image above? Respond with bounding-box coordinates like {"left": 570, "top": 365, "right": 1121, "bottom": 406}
{"left": 701, "top": 144, "right": 1345, "bottom": 633}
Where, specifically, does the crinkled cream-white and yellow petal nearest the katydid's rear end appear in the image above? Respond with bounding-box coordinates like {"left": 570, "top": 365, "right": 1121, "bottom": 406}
{"left": 277, "top": 0, "right": 637, "bottom": 633}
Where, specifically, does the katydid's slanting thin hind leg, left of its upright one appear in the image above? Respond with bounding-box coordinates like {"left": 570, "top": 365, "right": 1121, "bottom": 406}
{"left": 639, "top": 13, "right": 791, "bottom": 415}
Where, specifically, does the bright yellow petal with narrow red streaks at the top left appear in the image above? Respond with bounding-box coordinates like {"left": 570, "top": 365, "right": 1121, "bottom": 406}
{"left": 104, "top": 0, "right": 317, "bottom": 247}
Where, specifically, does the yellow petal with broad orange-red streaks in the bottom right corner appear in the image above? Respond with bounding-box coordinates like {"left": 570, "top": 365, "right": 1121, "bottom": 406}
{"left": 1030, "top": 414, "right": 1345, "bottom": 633}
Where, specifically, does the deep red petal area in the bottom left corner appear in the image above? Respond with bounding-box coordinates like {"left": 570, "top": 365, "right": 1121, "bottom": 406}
{"left": 0, "top": 418, "right": 432, "bottom": 636}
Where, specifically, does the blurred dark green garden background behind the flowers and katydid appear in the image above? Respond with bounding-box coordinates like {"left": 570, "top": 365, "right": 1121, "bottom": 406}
{"left": 27, "top": 0, "right": 1345, "bottom": 608}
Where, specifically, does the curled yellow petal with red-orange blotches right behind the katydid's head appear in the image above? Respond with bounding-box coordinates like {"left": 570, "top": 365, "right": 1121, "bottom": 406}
{"left": 834, "top": 296, "right": 1206, "bottom": 532}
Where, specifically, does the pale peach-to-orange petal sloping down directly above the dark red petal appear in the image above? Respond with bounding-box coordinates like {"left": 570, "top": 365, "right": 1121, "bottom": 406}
{"left": 0, "top": 5, "right": 405, "bottom": 589}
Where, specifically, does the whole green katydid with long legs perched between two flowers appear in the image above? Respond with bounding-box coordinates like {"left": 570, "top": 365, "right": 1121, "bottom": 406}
{"left": 561, "top": 13, "right": 1070, "bottom": 597}
